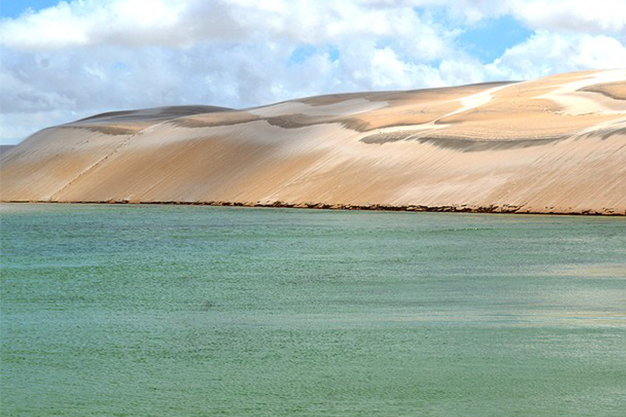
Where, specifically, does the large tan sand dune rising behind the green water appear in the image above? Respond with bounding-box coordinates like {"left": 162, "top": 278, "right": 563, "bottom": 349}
{"left": 0, "top": 70, "right": 626, "bottom": 214}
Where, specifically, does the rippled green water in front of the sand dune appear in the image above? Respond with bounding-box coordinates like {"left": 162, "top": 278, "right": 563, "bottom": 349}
{"left": 0, "top": 205, "right": 626, "bottom": 417}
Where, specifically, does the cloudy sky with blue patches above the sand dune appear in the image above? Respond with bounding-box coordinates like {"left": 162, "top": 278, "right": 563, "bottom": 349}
{"left": 0, "top": 0, "right": 626, "bottom": 144}
